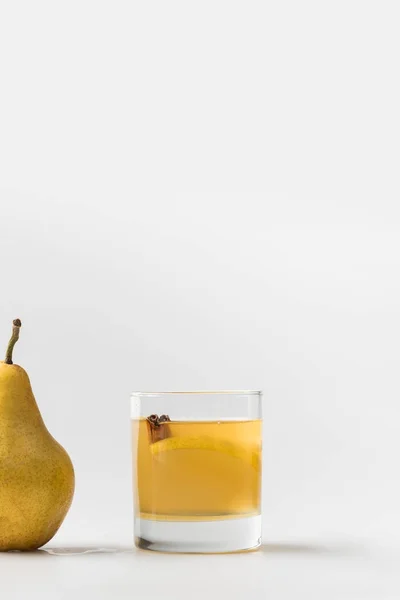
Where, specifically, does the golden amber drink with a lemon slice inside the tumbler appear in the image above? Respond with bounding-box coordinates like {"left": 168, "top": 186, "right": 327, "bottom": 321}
{"left": 132, "top": 419, "right": 261, "bottom": 521}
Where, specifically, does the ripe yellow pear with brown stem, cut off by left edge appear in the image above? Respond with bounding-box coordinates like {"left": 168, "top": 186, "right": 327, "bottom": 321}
{"left": 0, "top": 319, "right": 75, "bottom": 551}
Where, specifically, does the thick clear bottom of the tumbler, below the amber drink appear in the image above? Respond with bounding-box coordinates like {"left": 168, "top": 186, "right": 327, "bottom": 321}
{"left": 135, "top": 515, "right": 261, "bottom": 553}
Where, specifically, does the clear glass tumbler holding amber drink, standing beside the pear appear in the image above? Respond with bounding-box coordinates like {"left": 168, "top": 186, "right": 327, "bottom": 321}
{"left": 131, "top": 391, "right": 262, "bottom": 552}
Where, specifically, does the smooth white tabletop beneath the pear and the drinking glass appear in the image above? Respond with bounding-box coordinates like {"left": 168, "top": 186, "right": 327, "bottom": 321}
{"left": 0, "top": 541, "right": 400, "bottom": 600}
